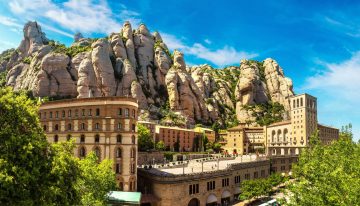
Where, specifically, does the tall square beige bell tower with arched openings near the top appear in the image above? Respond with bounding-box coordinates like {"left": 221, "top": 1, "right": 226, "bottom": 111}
{"left": 290, "top": 94, "right": 317, "bottom": 147}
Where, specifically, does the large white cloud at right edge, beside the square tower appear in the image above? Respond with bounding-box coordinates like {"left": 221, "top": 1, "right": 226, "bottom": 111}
{"left": 301, "top": 51, "right": 360, "bottom": 140}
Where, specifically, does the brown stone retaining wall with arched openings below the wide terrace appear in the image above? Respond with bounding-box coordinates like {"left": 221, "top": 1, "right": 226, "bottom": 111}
{"left": 139, "top": 164, "right": 270, "bottom": 206}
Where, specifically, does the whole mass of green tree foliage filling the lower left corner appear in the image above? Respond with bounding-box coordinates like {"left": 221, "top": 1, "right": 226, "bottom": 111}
{"left": 0, "top": 88, "right": 116, "bottom": 205}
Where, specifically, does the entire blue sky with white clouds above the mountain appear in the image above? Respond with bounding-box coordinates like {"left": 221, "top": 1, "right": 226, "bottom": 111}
{"left": 0, "top": 0, "right": 360, "bottom": 139}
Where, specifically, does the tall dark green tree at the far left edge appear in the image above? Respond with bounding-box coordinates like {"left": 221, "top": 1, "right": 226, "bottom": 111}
{"left": 0, "top": 88, "right": 51, "bottom": 205}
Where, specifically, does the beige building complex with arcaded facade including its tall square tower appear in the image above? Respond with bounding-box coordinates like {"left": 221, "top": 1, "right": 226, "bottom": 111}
{"left": 223, "top": 94, "right": 339, "bottom": 173}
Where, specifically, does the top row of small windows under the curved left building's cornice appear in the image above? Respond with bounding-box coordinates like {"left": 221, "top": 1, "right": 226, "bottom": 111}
{"left": 39, "top": 108, "right": 136, "bottom": 119}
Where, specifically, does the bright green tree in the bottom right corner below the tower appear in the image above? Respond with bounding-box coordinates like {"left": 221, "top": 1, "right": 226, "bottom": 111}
{"left": 285, "top": 129, "right": 360, "bottom": 206}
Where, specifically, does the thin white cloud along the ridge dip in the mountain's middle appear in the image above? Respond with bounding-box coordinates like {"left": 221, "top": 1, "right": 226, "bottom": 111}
{"left": 161, "top": 32, "right": 258, "bottom": 67}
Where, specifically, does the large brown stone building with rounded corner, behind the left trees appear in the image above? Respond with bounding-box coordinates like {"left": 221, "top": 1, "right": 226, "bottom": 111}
{"left": 39, "top": 97, "right": 138, "bottom": 191}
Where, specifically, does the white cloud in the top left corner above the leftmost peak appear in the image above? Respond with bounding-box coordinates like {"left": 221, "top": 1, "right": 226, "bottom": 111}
{"left": 9, "top": 0, "right": 140, "bottom": 33}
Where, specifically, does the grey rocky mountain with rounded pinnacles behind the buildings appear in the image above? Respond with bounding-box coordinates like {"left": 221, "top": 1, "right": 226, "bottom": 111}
{"left": 0, "top": 22, "right": 294, "bottom": 126}
